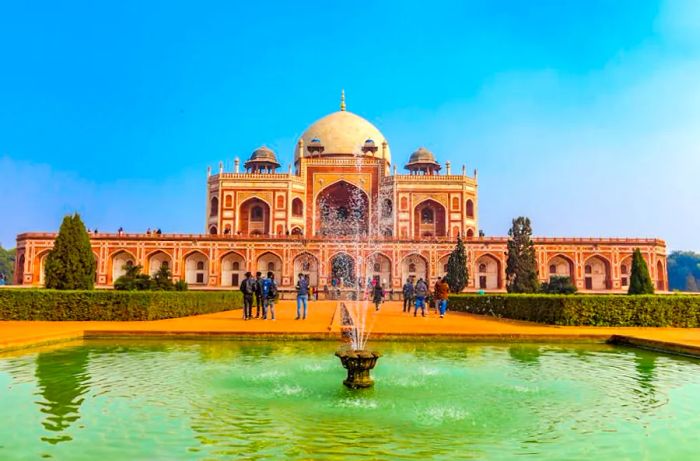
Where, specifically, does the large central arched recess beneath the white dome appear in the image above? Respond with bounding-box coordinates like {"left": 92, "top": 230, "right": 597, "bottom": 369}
{"left": 316, "top": 181, "right": 369, "bottom": 236}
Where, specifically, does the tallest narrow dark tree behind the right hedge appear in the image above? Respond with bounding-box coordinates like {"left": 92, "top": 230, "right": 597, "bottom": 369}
{"left": 506, "top": 216, "right": 539, "bottom": 293}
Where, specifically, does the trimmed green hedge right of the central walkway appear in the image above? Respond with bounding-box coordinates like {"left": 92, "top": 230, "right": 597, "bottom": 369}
{"left": 449, "top": 294, "right": 700, "bottom": 328}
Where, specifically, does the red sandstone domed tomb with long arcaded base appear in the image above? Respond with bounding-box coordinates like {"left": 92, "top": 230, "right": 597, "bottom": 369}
{"left": 10, "top": 94, "right": 668, "bottom": 292}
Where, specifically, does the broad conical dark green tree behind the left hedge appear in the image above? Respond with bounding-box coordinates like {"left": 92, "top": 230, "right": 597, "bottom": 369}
{"left": 45, "top": 213, "right": 96, "bottom": 290}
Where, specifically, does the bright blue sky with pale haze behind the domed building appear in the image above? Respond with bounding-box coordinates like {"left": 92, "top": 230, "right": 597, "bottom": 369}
{"left": 0, "top": 0, "right": 700, "bottom": 250}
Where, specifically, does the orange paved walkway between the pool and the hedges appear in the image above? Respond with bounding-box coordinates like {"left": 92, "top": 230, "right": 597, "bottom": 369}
{"left": 0, "top": 301, "right": 700, "bottom": 356}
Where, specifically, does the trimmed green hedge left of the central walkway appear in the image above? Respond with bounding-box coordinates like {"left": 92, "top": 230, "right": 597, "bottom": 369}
{"left": 0, "top": 289, "right": 243, "bottom": 320}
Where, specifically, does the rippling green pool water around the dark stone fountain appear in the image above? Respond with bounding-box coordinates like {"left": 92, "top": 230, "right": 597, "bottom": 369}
{"left": 0, "top": 340, "right": 700, "bottom": 461}
